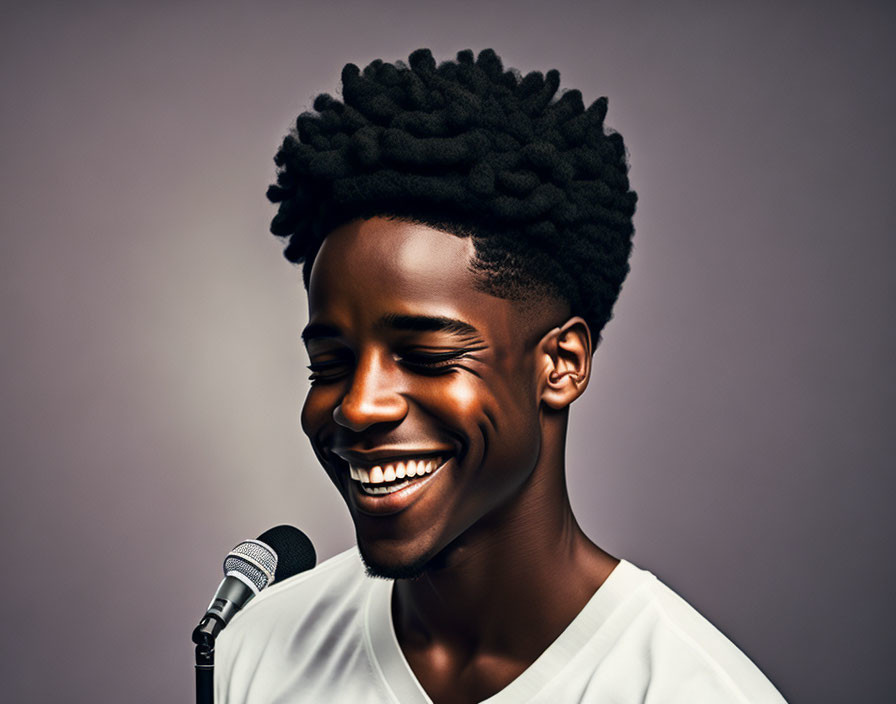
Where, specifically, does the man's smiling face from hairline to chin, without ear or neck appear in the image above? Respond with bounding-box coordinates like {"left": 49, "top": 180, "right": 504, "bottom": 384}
{"left": 302, "top": 218, "right": 557, "bottom": 577}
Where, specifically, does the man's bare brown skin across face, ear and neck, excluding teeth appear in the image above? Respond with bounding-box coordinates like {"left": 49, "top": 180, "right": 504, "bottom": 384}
{"left": 302, "top": 218, "right": 618, "bottom": 704}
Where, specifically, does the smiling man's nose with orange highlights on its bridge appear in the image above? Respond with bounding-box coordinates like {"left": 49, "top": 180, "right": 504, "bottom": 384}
{"left": 333, "top": 353, "right": 408, "bottom": 432}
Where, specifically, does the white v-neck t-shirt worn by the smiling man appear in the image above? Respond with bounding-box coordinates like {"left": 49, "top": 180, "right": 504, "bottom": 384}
{"left": 215, "top": 548, "right": 784, "bottom": 704}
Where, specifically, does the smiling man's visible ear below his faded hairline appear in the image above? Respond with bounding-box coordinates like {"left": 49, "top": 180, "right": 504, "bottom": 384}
{"left": 538, "top": 316, "right": 591, "bottom": 411}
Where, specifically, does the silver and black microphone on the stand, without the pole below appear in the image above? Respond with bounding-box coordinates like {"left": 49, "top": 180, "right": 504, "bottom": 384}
{"left": 193, "top": 525, "right": 317, "bottom": 650}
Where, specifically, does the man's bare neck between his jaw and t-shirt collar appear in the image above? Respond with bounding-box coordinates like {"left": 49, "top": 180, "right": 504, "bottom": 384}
{"left": 393, "top": 417, "right": 618, "bottom": 665}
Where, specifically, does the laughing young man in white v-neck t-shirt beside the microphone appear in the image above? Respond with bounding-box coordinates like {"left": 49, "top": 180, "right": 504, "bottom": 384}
{"left": 217, "top": 50, "right": 783, "bottom": 704}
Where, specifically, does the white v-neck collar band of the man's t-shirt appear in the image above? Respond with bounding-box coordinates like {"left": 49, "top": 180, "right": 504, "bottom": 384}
{"left": 364, "top": 560, "right": 651, "bottom": 704}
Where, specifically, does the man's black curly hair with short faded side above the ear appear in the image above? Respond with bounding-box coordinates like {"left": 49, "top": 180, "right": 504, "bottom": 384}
{"left": 267, "top": 49, "right": 637, "bottom": 346}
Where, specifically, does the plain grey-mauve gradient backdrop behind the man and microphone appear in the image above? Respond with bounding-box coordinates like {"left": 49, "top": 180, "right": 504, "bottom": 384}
{"left": 0, "top": 0, "right": 896, "bottom": 702}
